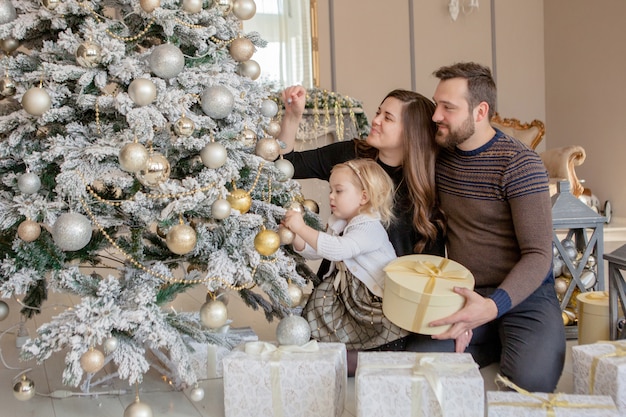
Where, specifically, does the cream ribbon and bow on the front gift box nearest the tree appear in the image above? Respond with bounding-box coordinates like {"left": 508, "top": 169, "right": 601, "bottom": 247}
{"left": 244, "top": 340, "right": 320, "bottom": 417}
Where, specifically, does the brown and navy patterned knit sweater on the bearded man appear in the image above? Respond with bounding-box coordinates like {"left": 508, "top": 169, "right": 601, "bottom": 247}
{"left": 437, "top": 130, "right": 553, "bottom": 317}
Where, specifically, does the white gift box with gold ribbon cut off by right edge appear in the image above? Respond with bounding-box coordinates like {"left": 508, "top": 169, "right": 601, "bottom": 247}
{"left": 572, "top": 341, "right": 626, "bottom": 415}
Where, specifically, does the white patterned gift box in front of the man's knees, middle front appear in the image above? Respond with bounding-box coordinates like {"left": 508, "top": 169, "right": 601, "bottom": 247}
{"left": 355, "top": 352, "right": 485, "bottom": 417}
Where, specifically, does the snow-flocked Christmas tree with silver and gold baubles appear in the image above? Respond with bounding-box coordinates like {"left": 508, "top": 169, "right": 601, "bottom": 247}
{"left": 0, "top": 0, "right": 317, "bottom": 390}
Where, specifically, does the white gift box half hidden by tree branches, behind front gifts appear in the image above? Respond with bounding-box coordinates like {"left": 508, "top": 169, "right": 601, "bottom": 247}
{"left": 186, "top": 327, "right": 259, "bottom": 379}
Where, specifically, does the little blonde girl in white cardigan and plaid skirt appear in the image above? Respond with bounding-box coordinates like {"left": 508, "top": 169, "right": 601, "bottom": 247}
{"left": 283, "top": 159, "right": 408, "bottom": 373}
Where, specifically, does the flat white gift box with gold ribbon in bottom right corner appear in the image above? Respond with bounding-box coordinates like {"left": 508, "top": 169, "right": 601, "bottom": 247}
{"left": 487, "top": 391, "right": 620, "bottom": 417}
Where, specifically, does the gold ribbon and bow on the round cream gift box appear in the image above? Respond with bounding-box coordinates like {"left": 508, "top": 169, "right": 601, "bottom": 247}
{"left": 385, "top": 258, "right": 467, "bottom": 329}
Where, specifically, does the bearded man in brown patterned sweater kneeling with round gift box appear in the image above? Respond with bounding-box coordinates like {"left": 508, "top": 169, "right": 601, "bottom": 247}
{"left": 431, "top": 63, "right": 565, "bottom": 392}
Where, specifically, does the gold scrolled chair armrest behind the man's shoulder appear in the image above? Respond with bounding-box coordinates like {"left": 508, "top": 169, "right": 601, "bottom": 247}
{"left": 541, "top": 145, "right": 587, "bottom": 197}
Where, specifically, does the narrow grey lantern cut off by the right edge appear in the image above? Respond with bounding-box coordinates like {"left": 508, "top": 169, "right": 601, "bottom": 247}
{"left": 604, "top": 245, "right": 626, "bottom": 340}
